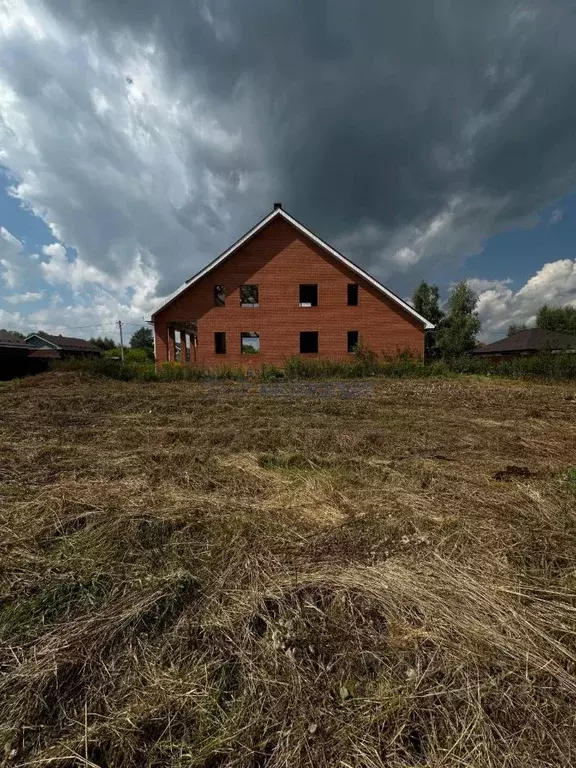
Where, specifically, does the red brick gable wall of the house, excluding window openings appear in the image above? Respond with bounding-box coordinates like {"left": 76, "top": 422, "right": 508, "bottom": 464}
{"left": 155, "top": 217, "right": 424, "bottom": 367}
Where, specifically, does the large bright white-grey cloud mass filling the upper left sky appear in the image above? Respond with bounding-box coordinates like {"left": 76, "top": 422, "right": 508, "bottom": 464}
{"left": 0, "top": 0, "right": 266, "bottom": 306}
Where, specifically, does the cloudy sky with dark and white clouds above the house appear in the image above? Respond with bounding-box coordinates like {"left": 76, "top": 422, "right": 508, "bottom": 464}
{"left": 0, "top": 0, "right": 576, "bottom": 338}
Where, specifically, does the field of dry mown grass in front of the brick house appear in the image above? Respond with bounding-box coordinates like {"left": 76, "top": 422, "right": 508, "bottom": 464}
{"left": 0, "top": 373, "right": 576, "bottom": 768}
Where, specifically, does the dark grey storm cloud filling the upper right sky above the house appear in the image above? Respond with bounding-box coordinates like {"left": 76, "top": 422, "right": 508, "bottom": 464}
{"left": 5, "top": 0, "right": 576, "bottom": 296}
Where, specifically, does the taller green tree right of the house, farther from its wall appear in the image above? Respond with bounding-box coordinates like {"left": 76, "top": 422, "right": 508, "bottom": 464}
{"left": 438, "top": 280, "right": 481, "bottom": 359}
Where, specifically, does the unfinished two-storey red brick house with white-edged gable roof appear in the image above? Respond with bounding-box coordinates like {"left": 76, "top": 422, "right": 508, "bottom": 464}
{"left": 152, "top": 203, "right": 433, "bottom": 367}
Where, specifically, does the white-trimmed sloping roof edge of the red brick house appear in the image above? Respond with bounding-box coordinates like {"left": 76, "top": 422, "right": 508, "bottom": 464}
{"left": 152, "top": 206, "right": 434, "bottom": 329}
